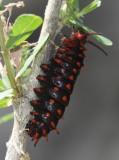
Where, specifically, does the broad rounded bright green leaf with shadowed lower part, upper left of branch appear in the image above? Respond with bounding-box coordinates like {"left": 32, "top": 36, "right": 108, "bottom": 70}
{"left": 6, "top": 14, "right": 42, "bottom": 49}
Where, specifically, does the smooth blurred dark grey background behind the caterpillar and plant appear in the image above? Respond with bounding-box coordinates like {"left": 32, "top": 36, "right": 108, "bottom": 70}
{"left": 0, "top": 0, "right": 119, "bottom": 160}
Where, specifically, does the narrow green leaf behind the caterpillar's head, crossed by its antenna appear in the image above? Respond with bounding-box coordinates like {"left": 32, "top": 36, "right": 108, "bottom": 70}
{"left": 70, "top": 21, "right": 113, "bottom": 46}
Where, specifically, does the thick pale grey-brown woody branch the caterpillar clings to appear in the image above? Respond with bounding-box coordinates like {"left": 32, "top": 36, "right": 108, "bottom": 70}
{"left": 5, "top": 0, "right": 63, "bottom": 160}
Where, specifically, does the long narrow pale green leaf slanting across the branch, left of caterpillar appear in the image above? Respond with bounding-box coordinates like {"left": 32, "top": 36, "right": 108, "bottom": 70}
{"left": 15, "top": 34, "right": 49, "bottom": 79}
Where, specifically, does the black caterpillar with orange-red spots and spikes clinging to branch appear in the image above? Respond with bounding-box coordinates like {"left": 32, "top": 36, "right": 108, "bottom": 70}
{"left": 26, "top": 30, "right": 107, "bottom": 146}
